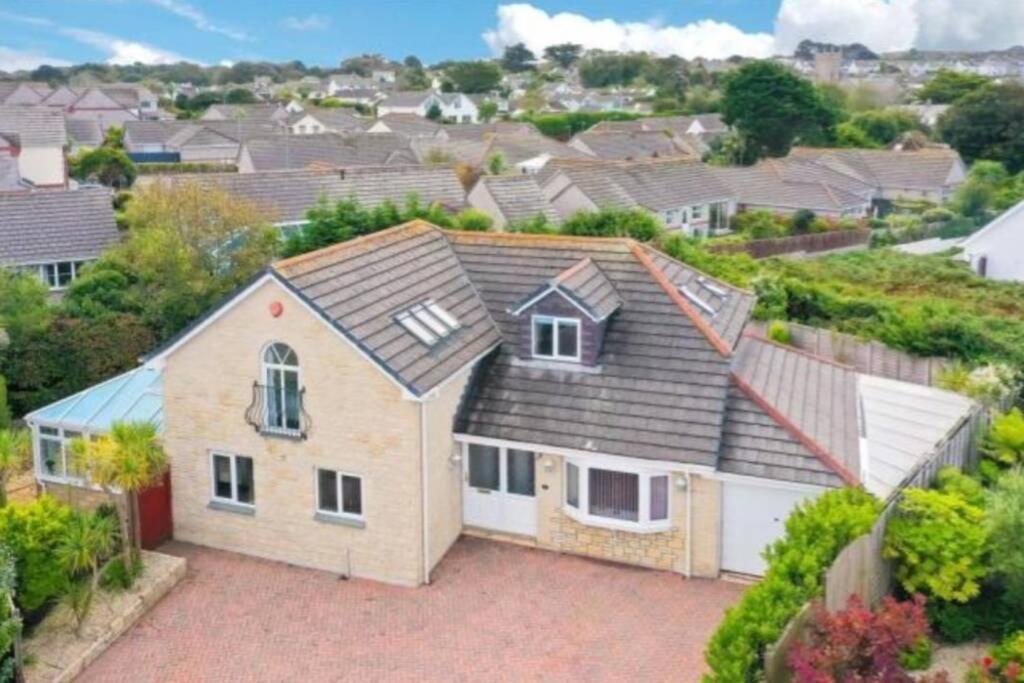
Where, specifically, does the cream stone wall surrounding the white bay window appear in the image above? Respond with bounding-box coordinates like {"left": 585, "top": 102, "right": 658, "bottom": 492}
{"left": 537, "top": 455, "right": 721, "bottom": 577}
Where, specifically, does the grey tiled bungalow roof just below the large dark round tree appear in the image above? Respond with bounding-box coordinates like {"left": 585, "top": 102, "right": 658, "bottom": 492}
{"left": 708, "top": 159, "right": 877, "bottom": 218}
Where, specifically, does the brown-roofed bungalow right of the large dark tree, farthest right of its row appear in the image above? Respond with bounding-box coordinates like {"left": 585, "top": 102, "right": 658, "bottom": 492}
{"left": 787, "top": 147, "right": 967, "bottom": 204}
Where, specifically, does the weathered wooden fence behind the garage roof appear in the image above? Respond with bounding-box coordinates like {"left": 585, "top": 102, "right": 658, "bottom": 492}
{"left": 751, "top": 322, "right": 951, "bottom": 386}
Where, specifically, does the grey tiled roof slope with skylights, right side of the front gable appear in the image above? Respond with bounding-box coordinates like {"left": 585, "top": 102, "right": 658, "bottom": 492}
{"left": 274, "top": 221, "right": 501, "bottom": 395}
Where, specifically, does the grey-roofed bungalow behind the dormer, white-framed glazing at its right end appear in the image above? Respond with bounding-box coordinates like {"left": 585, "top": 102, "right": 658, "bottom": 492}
{"left": 538, "top": 159, "right": 736, "bottom": 237}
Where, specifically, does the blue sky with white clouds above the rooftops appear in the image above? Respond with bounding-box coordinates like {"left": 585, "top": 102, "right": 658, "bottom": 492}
{"left": 0, "top": 0, "right": 1024, "bottom": 71}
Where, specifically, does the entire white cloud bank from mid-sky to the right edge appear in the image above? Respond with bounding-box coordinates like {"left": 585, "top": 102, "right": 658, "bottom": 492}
{"left": 482, "top": 0, "right": 1024, "bottom": 58}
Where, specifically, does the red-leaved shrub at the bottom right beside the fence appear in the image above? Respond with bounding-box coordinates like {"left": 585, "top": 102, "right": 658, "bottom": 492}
{"left": 788, "top": 595, "right": 928, "bottom": 683}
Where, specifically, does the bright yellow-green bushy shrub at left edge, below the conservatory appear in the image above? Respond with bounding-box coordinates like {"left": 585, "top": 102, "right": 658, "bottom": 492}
{"left": 0, "top": 496, "right": 77, "bottom": 614}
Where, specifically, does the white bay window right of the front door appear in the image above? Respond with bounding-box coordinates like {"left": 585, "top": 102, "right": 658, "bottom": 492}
{"left": 563, "top": 458, "right": 671, "bottom": 532}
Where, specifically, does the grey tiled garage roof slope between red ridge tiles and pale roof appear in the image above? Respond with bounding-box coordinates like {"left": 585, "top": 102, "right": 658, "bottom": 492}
{"left": 733, "top": 336, "right": 861, "bottom": 483}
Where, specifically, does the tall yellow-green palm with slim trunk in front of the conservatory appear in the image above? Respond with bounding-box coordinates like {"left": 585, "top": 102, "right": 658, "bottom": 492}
{"left": 72, "top": 422, "right": 167, "bottom": 570}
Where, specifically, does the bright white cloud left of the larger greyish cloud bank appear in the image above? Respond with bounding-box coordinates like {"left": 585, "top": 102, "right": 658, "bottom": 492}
{"left": 483, "top": 4, "right": 774, "bottom": 57}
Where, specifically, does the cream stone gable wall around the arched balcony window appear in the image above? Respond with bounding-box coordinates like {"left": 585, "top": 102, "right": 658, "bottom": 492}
{"left": 164, "top": 283, "right": 436, "bottom": 585}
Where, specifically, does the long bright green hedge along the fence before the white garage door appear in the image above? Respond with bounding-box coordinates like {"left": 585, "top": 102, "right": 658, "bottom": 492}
{"left": 705, "top": 488, "right": 881, "bottom": 683}
